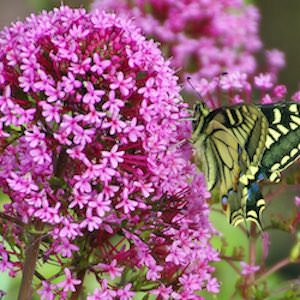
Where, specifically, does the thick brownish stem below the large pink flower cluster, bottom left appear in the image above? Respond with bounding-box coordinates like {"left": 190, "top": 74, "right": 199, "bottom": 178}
{"left": 18, "top": 234, "right": 41, "bottom": 300}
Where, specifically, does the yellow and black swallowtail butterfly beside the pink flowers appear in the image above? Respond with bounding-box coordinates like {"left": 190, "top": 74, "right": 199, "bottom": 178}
{"left": 191, "top": 102, "right": 300, "bottom": 228}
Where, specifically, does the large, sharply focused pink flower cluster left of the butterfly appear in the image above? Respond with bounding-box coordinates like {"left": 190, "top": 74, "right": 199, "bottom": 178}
{"left": 0, "top": 6, "right": 218, "bottom": 299}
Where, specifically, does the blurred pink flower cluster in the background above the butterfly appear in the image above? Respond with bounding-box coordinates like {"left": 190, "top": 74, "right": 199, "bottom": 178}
{"left": 92, "top": 0, "right": 285, "bottom": 81}
